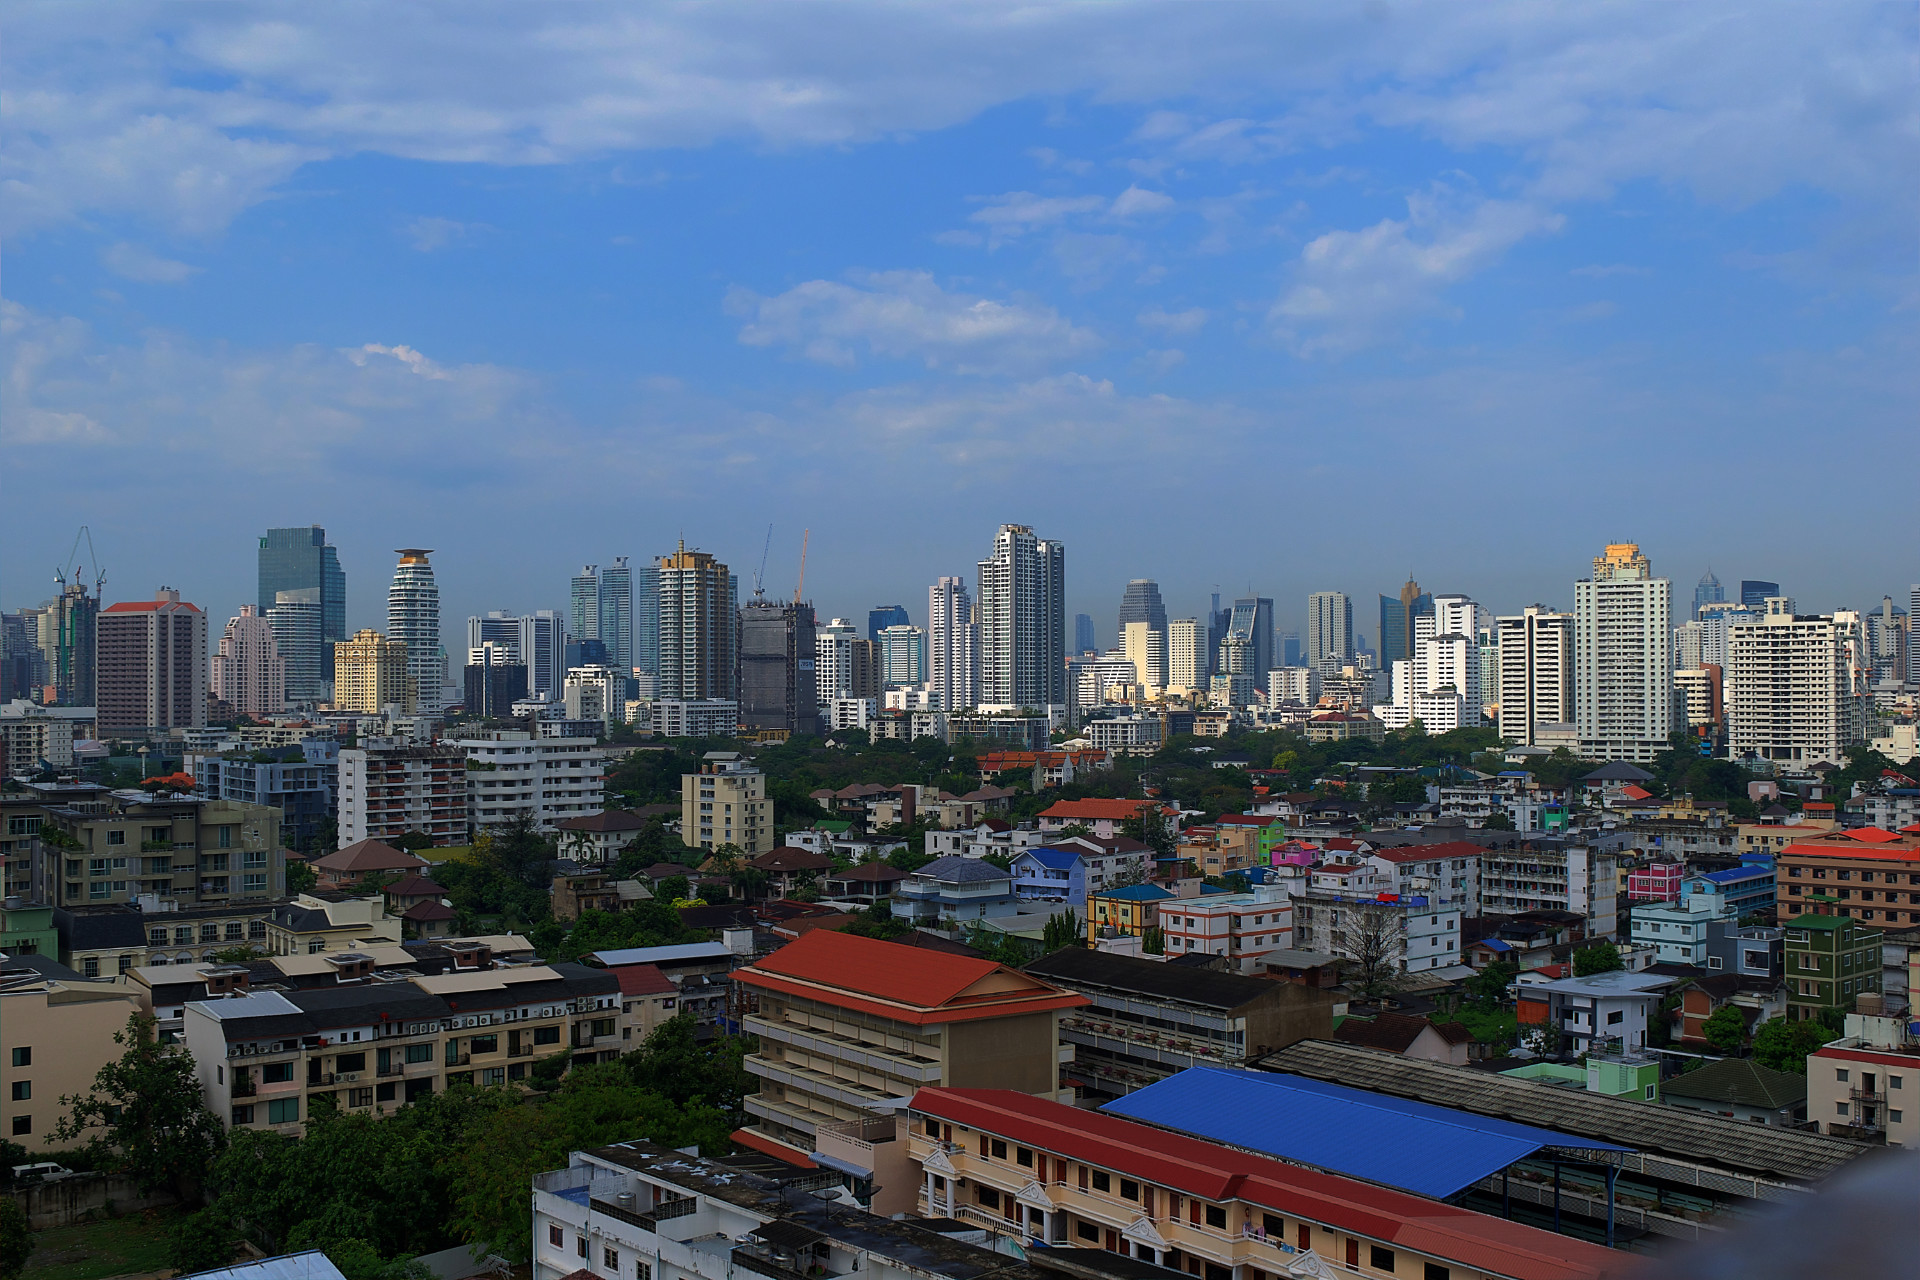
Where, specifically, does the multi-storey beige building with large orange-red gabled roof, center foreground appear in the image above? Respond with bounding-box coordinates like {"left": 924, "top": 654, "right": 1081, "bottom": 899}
{"left": 733, "top": 929, "right": 1089, "bottom": 1176}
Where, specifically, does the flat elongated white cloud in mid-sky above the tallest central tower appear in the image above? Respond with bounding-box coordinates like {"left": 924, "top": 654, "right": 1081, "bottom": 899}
{"left": 728, "top": 271, "right": 1098, "bottom": 374}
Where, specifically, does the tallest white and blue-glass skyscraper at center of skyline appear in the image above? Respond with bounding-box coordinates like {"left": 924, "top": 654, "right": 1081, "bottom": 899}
{"left": 979, "top": 524, "right": 1068, "bottom": 710}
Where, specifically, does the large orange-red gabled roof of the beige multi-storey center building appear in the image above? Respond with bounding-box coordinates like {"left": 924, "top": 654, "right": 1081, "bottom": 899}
{"left": 733, "top": 929, "right": 1091, "bottom": 1027}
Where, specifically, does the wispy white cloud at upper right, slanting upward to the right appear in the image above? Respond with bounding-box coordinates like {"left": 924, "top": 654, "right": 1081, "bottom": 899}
{"left": 1267, "top": 190, "right": 1563, "bottom": 357}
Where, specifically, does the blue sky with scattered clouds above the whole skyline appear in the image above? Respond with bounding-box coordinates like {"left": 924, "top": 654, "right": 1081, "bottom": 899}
{"left": 0, "top": 0, "right": 1920, "bottom": 643}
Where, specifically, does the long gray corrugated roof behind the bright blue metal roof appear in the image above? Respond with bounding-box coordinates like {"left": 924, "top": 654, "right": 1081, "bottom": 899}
{"left": 1258, "top": 1040, "right": 1870, "bottom": 1182}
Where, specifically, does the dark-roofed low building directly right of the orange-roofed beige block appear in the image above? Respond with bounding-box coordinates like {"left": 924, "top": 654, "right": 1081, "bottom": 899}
{"left": 1027, "top": 946, "right": 1332, "bottom": 1096}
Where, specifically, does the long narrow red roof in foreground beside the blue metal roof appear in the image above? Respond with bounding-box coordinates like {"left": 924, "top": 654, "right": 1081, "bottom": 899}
{"left": 914, "top": 1088, "right": 1632, "bottom": 1280}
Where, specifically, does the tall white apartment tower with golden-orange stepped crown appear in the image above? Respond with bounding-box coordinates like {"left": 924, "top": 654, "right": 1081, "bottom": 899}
{"left": 1572, "top": 543, "right": 1674, "bottom": 764}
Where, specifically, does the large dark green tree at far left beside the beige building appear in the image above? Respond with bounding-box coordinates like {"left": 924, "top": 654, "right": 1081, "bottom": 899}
{"left": 54, "top": 1013, "right": 225, "bottom": 1197}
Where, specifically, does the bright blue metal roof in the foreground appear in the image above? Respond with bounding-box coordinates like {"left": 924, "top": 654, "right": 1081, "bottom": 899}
{"left": 1102, "top": 1067, "right": 1628, "bottom": 1199}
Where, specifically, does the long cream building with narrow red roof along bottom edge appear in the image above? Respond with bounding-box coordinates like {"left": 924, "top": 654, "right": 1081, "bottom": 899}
{"left": 908, "top": 1088, "right": 1620, "bottom": 1280}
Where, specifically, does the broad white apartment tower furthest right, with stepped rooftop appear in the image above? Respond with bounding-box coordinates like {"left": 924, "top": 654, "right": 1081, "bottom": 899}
{"left": 1724, "top": 597, "right": 1866, "bottom": 764}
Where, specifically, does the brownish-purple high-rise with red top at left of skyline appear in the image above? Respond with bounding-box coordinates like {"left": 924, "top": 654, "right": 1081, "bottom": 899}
{"left": 94, "top": 587, "right": 207, "bottom": 737}
